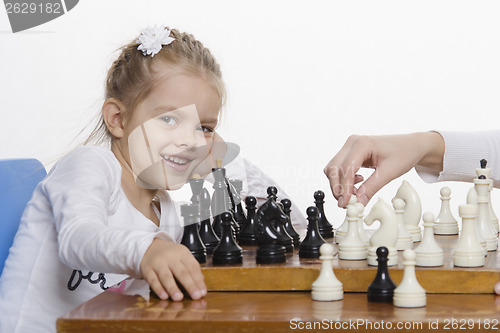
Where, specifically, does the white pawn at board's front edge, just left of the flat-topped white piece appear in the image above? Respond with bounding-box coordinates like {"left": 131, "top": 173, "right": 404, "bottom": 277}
{"left": 415, "top": 212, "right": 444, "bottom": 267}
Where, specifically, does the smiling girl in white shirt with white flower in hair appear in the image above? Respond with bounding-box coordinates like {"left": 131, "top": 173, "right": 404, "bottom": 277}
{"left": 0, "top": 27, "right": 225, "bottom": 332}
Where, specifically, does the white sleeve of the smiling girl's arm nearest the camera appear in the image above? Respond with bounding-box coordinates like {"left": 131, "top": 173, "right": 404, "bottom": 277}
{"left": 42, "top": 147, "right": 157, "bottom": 277}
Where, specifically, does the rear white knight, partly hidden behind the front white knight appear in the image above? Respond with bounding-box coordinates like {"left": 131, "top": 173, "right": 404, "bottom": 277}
{"left": 395, "top": 180, "right": 422, "bottom": 242}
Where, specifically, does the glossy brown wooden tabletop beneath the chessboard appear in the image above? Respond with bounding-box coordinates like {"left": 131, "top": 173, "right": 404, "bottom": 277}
{"left": 57, "top": 292, "right": 500, "bottom": 333}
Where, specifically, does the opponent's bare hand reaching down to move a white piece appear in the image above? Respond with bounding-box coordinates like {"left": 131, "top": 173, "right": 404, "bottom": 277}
{"left": 324, "top": 132, "right": 444, "bottom": 207}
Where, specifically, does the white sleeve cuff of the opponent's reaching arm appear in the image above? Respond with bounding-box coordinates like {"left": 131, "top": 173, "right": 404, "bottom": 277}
{"left": 415, "top": 130, "right": 500, "bottom": 187}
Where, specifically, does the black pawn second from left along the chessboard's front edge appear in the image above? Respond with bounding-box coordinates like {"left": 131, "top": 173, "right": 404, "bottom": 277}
{"left": 212, "top": 212, "right": 243, "bottom": 265}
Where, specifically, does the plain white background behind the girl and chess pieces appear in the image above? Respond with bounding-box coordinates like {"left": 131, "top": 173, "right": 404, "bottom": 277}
{"left": 0, "top": 0, "right": 500, "bottom": 226}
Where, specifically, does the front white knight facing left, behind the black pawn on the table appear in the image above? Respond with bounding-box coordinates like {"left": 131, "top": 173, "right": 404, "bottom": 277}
{"left": 365, "top": 199, "right": 399, "bottom": 266}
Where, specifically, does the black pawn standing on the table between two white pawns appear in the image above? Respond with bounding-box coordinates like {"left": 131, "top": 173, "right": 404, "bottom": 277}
{"left": 367, "top": 246, "right": 396, "bottom": 303}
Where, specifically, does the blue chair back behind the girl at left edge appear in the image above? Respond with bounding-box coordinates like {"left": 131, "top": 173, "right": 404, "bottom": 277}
{"left": 0, "top": 159, "right": 47, "bottom": 275}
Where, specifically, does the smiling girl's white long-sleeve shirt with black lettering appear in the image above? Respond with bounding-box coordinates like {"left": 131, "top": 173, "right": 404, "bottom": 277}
{"left": 0, "top": 147, "right": 183, "bottom": 333}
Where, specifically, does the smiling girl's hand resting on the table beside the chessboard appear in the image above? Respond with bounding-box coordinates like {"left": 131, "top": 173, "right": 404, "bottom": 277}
{"left": 140, "top": 238, "right": 207, "bottom": 301}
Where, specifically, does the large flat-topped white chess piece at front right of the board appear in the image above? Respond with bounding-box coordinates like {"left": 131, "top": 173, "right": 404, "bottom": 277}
{"left": 453, "top": 205, "right": 485, "bottom": 267}
